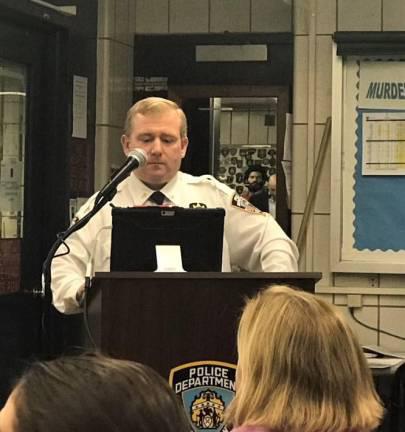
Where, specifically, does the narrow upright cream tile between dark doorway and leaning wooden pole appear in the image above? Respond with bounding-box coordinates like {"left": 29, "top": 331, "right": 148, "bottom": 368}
{"left": 291, "top": 125, "right": 308, "bottom": 213}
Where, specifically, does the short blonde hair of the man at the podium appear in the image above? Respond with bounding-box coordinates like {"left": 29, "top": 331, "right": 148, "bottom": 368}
{"left": 124, "top": 97, "right": 187, "bottom": 138}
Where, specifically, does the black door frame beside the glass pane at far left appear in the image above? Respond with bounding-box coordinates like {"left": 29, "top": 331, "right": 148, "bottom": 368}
{"left": 0, "top": 10, "right": 70, "bottom": 291}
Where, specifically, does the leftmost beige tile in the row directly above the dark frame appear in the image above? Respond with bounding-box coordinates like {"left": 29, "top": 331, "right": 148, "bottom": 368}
{"left": 135, "top": 0, "right": 169, "bottom": 33}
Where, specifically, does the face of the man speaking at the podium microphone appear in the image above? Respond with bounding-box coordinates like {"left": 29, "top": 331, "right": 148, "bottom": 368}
{"left": 121, "top": 110, "right": 188, "bottom": 189}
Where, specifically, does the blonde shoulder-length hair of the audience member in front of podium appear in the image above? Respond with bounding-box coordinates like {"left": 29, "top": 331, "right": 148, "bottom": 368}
{"left": 226, "top": 286, "right": 383, "bottom": 432}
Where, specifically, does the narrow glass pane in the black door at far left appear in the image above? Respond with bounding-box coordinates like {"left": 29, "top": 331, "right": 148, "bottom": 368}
{"left": 0, "top": 59, "right": 27, "bottom": 239}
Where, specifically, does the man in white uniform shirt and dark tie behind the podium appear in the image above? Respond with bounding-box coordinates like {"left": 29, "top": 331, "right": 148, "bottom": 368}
{"left": 51, "top": 97, "right": 298, "bottom": 313}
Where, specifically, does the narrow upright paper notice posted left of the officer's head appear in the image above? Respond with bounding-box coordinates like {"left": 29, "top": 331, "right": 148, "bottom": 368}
{"left": 72, "top": 75, "right": 88, "bottom": 139}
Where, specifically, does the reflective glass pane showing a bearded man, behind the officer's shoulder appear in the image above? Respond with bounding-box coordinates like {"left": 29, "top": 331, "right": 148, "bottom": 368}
{"left": 211, "top": 97, "right": 277, "bottom": 214}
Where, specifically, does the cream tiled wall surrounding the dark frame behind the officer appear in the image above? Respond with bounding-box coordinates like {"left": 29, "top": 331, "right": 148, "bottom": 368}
{"left": 96, "top": 0, "right": 405, "bottom": 351}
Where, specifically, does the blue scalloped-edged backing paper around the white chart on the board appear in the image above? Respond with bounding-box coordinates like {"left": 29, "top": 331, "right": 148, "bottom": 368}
{"left": 353, "top": 108, "right": 405, "bottom": 252}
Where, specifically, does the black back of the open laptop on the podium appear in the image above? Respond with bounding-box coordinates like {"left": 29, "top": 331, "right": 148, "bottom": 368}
{"left": 111, "top": 207, "right": 225, "bottom": 272}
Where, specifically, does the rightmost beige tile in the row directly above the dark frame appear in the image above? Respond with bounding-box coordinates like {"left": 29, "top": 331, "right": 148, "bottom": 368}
{"left": 251, "top": 0, "right": 292, "bottom": 33}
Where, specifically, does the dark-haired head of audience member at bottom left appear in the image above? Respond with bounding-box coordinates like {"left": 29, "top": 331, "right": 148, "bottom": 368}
{"left": 14, "top": 355, "right": 189, "bottom": 432}
